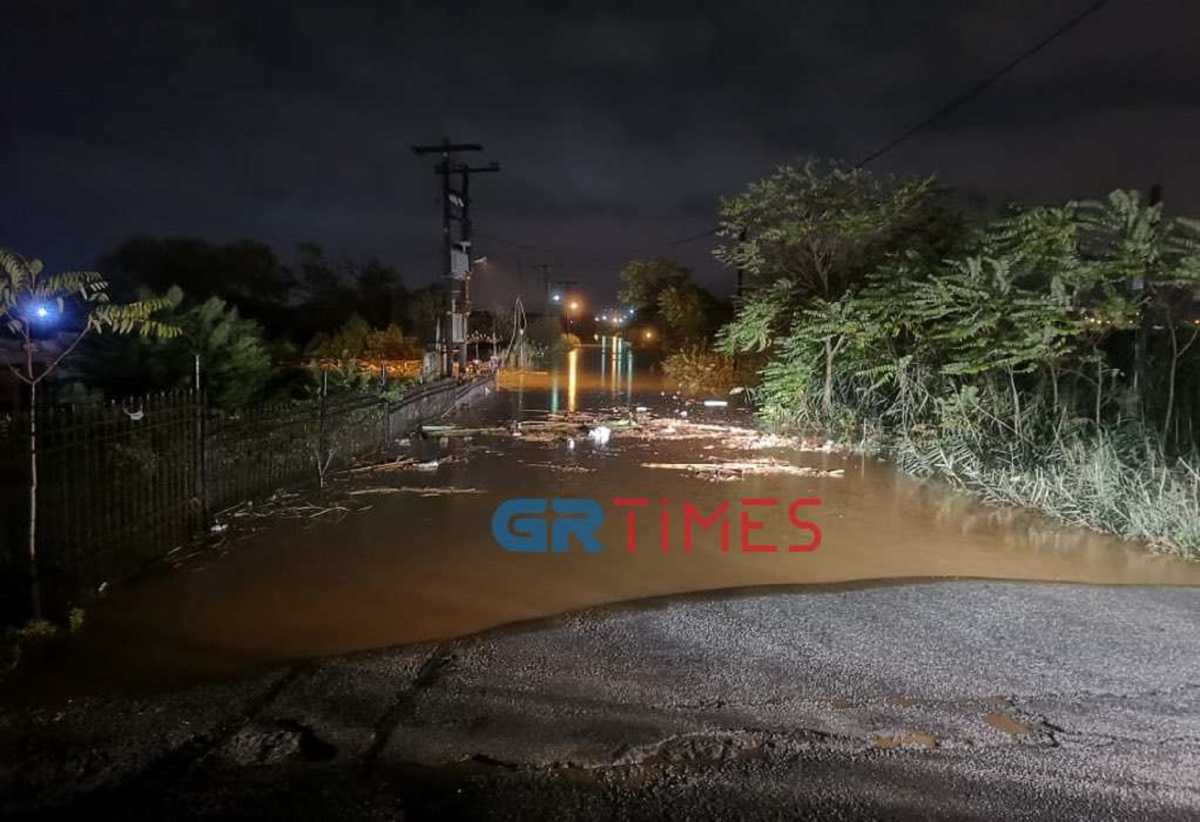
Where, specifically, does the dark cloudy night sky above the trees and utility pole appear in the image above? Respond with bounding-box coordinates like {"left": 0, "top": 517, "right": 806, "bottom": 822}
{"left": 0, "top": 0, "right": 1200, "bottom": 300}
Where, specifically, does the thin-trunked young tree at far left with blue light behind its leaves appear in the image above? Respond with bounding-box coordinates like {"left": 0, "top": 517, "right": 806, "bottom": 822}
{"left": 0, "top": 248, "right": 179, "bottom": 619}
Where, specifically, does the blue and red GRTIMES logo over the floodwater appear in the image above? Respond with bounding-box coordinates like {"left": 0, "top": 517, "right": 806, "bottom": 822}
{"left": 492, "top": 497, "right": 821, "bottom": 553}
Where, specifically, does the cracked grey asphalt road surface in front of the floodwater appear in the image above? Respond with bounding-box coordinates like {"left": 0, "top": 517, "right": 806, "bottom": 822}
{"left": 0, "top": 581, "right": 1200, "bottom": 820}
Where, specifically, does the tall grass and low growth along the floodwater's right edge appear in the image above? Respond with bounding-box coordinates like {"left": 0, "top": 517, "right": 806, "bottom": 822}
{"left": 756, "top": 364, "right": 1200, "bottom": 560}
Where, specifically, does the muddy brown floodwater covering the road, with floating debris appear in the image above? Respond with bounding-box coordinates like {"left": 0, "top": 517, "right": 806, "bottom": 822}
{"left": 16, "top": 347, "right": 1200, "bottom": 690}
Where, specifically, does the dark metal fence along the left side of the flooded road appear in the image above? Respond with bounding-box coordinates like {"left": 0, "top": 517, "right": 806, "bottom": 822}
{"left": 0, "top": 378, "right": 490, "bottom": 619}
